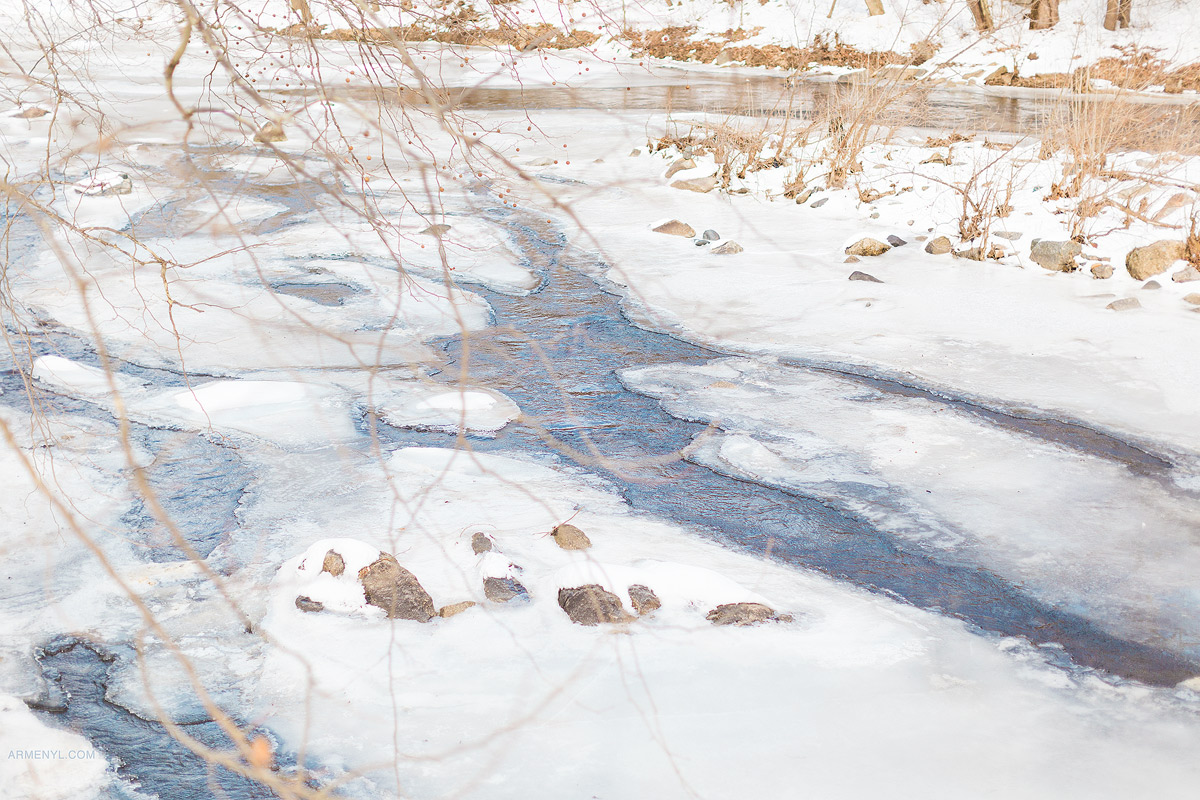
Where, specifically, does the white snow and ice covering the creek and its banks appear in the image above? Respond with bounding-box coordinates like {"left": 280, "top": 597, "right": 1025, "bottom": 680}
{"left": 0, "top": 0, "right": 1200, "bottom": 798}
